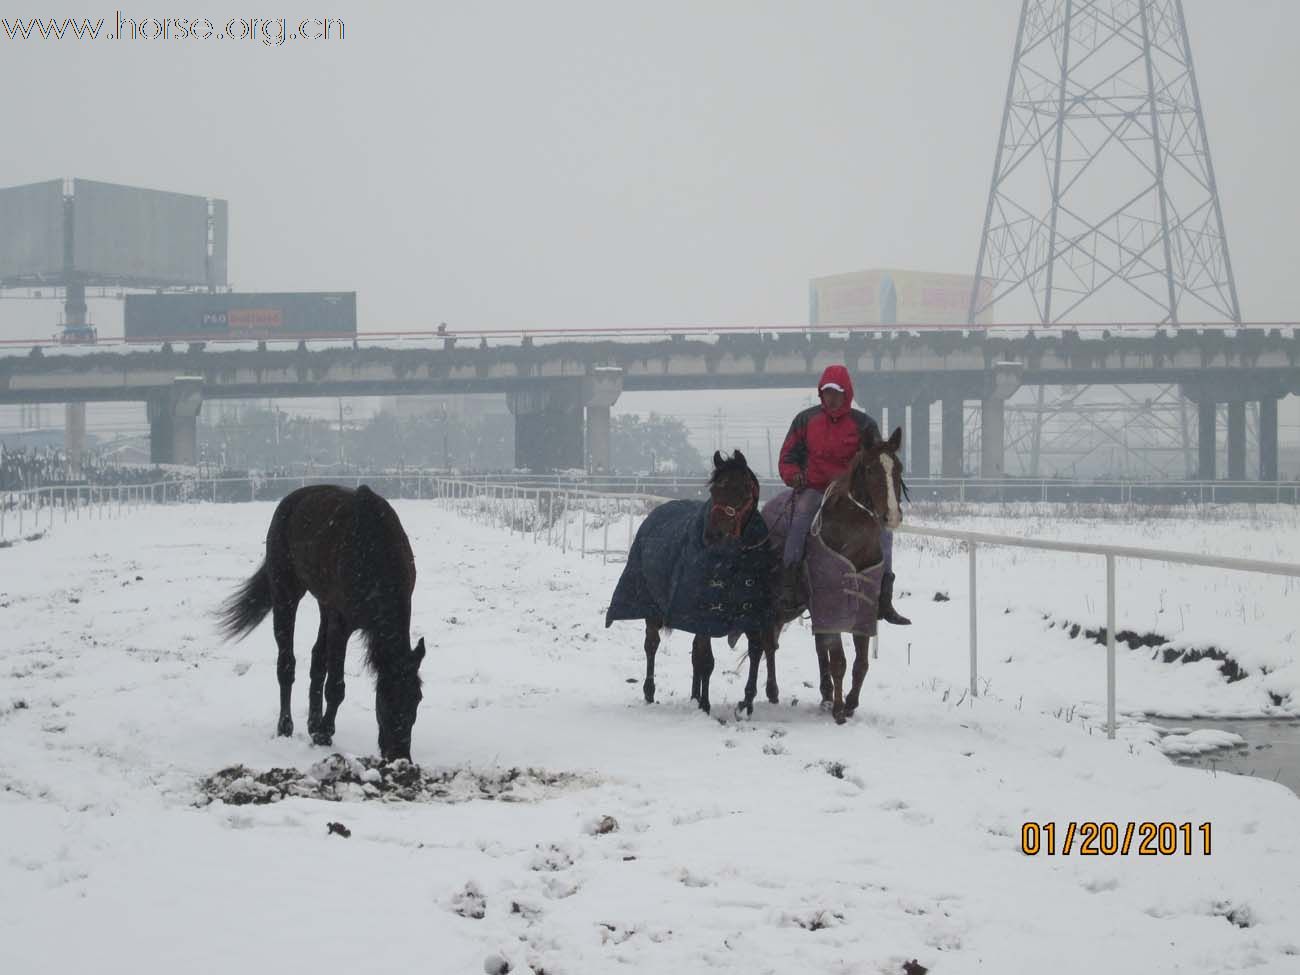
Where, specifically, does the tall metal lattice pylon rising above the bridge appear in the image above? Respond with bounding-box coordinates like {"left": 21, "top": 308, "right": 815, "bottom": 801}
{"left": 970, "top": 0, "right": 1242, "bottom": 324}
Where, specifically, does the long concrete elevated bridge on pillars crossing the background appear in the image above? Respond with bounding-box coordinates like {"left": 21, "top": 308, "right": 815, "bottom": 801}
{"left": 0, "top": 322, "right": 1300, "bottom": 480}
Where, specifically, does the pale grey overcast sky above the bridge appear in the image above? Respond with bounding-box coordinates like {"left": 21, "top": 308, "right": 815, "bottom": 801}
{"left": 0, "top": 0, "right": 1300, "bottom": 335}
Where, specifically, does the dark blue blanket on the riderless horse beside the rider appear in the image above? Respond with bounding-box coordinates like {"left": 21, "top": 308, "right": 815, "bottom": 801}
{"left": 605, "top": 501, "right": 775, "bottom": 637}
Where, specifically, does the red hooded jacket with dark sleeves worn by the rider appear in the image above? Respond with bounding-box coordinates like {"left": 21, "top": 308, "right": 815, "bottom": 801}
{"left": 780, "top": 365, "right": 880, "bottom": 491}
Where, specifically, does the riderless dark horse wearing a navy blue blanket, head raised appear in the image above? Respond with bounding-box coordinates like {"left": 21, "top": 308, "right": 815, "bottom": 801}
{"left": 605, "top": 450, "right": 772, "bottom": 712}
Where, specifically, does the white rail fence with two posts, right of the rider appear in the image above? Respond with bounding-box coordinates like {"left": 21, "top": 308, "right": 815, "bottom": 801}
{"left": 897, "top": 524, "right": 1300, "bottom": 738}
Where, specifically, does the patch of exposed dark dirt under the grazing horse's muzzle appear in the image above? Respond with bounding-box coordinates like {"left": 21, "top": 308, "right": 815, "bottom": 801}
{"left": 195, "top": 754, "right": 595, "bottom": 806}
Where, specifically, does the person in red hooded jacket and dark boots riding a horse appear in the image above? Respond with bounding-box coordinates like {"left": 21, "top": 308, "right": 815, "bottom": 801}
{"left": 780, "top": 365, "right": 911, "bottom": 627}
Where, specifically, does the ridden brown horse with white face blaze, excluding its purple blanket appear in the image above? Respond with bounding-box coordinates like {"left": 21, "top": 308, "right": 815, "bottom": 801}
{"left": 736, "top": 429, "right": 907, "bottom": 724}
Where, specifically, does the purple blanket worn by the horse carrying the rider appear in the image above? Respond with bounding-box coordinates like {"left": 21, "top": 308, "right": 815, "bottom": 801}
{"left": 763, "top": 491, "right": 885, "bottom": 637}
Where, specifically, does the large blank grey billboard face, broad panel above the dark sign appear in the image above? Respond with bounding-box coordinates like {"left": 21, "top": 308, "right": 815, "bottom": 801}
{"left": 73, "top": 179, "right": 216, "bottom": 286}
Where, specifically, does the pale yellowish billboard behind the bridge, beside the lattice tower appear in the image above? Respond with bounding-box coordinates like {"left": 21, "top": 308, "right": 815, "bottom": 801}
{"left": 809, "top": 270, "right": 993, "bottom": 325}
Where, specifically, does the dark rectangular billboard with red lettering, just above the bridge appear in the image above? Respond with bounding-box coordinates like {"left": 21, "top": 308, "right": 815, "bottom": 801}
{"left": 124, "top": 291, "right": 356, "bottom": 342}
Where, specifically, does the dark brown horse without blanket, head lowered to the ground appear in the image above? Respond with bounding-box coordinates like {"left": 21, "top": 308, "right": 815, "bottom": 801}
{"left": 218, "top": 484, "right": 424, "bottom": 761}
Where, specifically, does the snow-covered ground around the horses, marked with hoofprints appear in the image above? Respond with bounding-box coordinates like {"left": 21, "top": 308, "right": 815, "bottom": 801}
{"left": 0, "top": 502, "right": 1300, "bottom": 975}
